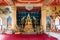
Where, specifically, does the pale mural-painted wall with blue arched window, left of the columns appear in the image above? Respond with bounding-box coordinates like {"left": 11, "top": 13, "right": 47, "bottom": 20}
{"left": 0, "top": 6, "right": 12, "bottom": 34}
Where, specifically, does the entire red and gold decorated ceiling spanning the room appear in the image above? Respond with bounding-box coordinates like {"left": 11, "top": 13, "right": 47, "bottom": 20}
{"left": 0, "top": 0, "right": 60, "bottom": 6}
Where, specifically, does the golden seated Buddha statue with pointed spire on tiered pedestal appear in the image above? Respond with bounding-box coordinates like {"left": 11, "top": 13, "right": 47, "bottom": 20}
{"left": 24, "top": 14, "right": 34, "bottom": 33}
